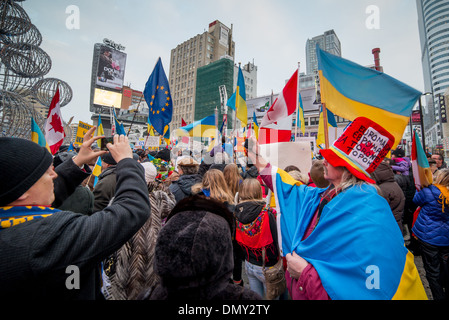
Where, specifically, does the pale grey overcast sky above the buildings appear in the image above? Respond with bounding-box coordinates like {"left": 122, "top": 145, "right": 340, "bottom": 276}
{"left": 21, "top": 0, "right": 424, "bottom": 123}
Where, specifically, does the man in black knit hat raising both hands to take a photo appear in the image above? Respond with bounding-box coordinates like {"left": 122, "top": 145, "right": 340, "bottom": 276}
{"left": 0, "top": 127, "right": 150, "bottom": 302}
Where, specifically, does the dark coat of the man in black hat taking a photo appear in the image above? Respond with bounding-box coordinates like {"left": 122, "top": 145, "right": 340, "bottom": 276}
{"left": 0, "top": 159, "right": 150, "bottom": 302}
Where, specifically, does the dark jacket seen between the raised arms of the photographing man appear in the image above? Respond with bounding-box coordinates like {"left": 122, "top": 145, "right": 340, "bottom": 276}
{"left": 93, "top": 165, "right": 117, "bottom": 212}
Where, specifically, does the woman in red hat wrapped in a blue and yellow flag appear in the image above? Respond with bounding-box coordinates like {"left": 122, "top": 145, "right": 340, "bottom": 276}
{"left": 249, "top": 118, "right": 427, "bottom": 300}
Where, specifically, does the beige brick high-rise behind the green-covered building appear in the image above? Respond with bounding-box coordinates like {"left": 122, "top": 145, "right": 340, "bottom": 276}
{"left": 168, "top": 20, "right": 235, "bottom": 127}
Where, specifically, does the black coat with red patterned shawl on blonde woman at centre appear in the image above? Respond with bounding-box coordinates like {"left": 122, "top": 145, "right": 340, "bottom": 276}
{"left": 234, "top": 200, "right": 279, "bottom": 267}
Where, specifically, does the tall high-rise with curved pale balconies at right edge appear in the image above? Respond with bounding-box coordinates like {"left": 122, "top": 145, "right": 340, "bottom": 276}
{"left": 416, "top": 0, "right": 449, "bottom": 151}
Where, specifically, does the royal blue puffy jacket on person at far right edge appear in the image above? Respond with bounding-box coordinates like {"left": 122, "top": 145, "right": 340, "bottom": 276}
{"left": 412, "top": 185, "right": 449, "bottom": 246}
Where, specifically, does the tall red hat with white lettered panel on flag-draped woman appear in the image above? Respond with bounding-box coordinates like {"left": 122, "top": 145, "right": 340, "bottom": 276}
{"left": 320, "top": 117, "right": 394, "bottom": 183}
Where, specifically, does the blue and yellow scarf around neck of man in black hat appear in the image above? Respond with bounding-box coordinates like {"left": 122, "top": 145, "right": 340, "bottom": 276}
{"left": 0, "top": 206, "right": 60, "bottom": 230}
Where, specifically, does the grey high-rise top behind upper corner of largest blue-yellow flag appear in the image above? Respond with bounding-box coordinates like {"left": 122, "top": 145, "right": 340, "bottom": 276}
{"left": 306, "top": 30, "right": 341, "bottom": 75}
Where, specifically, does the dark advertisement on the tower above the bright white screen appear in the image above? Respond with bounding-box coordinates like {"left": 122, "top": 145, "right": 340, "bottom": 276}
{"left": 96, "top": 45, "right": 126, "bottom": 90}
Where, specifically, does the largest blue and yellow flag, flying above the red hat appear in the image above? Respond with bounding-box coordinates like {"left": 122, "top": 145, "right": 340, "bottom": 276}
{"left": 316, "top": 45, "right": 421, "bottom": 149}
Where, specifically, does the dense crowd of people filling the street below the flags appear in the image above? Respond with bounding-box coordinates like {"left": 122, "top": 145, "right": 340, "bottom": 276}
{"left": 0, "top": 119, "right": 449, "bottom": 300}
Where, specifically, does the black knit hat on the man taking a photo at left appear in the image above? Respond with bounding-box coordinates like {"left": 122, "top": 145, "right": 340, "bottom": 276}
{"left": 0, "top": 137, "right": 53, "bottom": 206}
